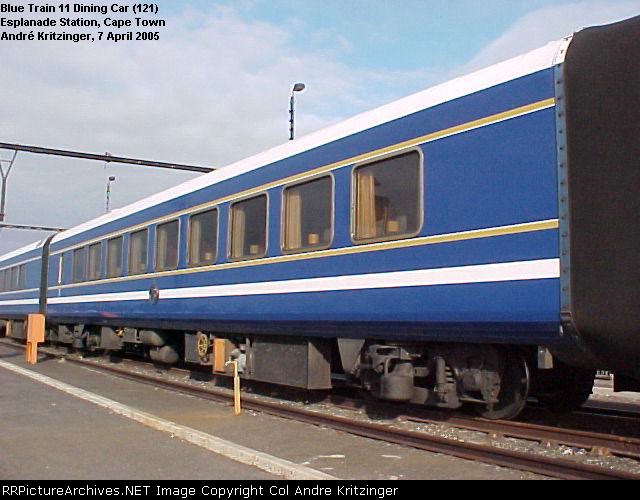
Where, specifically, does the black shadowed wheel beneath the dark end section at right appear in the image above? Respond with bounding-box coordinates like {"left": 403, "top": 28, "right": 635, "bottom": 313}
{"left": 535, "top": 360, "right": 596, "bottom": 413}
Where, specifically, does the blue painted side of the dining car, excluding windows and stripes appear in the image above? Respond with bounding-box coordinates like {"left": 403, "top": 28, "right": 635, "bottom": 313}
{"left": 0, "top": 69, "right": 562, "bottom": 344}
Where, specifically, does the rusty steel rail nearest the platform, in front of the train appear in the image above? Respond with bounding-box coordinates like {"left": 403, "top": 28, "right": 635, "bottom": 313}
{"left": 1, "top": 342, "right": 640, "bottom": 480}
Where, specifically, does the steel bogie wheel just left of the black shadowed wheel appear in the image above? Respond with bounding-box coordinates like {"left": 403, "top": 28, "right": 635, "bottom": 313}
{"left": 475, "top": 352, "right": 530, "bottom": 420}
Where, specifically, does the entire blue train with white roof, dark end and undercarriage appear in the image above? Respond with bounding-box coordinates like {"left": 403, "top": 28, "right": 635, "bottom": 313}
{"left": 0, "top": 18, "right": 640, "bottom": 418}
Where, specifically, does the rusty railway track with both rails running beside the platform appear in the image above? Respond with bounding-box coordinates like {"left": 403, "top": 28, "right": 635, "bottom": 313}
{"left": 0, "top": 340, "right": 640, "bottom": 480}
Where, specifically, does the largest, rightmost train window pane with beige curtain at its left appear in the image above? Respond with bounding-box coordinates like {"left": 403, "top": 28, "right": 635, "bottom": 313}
{"left": 353, "top": 151, "right": 422, "bottom": 241}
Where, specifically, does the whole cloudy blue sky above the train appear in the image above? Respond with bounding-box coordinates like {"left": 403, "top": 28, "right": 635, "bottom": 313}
{"left": 0, "top": 0, "right": 640, "bottom": 254}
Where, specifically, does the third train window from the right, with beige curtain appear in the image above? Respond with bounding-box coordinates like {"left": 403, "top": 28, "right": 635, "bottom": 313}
{"left": 230, "top": 195, "right": 267, "bottom": 260}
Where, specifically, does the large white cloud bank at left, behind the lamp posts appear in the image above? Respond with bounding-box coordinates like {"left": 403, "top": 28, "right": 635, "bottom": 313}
{"left": 0, "top": 2, "right": 426, "bottom": 254}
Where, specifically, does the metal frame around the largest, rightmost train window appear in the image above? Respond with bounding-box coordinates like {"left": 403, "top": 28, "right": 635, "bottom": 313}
{"left": 349, "top": 147, "right": 425, "bottom": 245}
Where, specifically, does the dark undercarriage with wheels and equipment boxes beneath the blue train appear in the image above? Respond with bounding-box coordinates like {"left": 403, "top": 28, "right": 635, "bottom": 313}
{"left": 6, "top": 321, "right": 595, "bottom": 420}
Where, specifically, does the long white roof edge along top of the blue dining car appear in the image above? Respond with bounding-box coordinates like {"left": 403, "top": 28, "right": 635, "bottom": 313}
{"left": 5, "top": 35, "right": 572, "bottom": 259}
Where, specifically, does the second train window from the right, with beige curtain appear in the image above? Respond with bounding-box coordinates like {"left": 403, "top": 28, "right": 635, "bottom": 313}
{"left": 282, "top": 177, "right": 333, "bottom": 252}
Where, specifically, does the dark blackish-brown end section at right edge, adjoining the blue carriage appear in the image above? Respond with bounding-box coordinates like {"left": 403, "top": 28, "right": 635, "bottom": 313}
{"left": 563, "top": 16, "right": 640, "bottom": 378}
